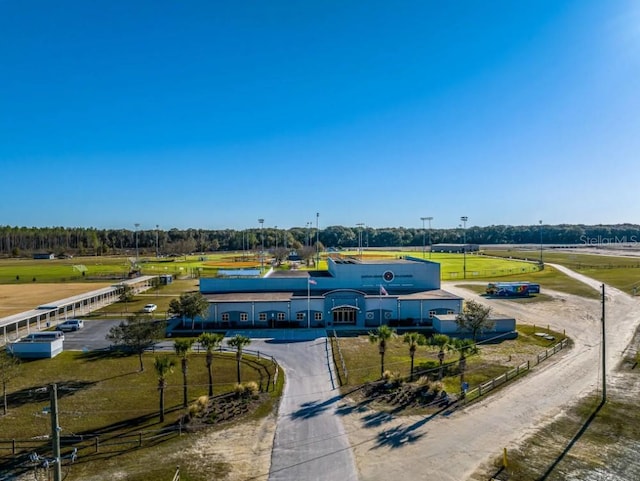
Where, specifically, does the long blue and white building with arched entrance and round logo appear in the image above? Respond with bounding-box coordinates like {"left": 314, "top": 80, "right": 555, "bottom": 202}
{"left": 200, "top": 257, "right": 462, "bottom": 329}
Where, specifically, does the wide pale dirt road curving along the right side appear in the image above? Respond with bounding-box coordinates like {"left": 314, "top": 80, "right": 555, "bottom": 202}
{"left": 344, "top": 266, "right": 639, "bottom": 481}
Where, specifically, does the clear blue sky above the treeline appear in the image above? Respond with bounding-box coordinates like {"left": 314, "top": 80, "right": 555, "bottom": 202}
{"left": 0, "top": 0, "right": 640, "bottom": 229}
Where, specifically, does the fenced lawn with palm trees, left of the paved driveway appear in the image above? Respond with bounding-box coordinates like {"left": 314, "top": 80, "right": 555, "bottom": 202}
{"left": 0, "top": 344, "right": 275, "bottom": 439}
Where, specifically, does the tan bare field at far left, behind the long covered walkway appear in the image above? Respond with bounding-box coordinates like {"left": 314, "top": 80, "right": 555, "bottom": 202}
{"left": 0, "top": 282, "right": 112, "bottom": 318}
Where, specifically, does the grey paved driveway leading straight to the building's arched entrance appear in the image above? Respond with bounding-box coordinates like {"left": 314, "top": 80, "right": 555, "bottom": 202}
{"left": 239, "top": 330, "right": 358, "bottom": 481}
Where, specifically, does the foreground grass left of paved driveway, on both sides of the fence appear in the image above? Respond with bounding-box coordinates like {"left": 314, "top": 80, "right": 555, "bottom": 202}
{"left": 0, "top": 344, "right": 284, "bottom": 481}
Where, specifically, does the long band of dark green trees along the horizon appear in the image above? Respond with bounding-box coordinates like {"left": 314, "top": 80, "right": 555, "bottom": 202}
{"left": 0, "top": 224, "right": 640, "bottom": 256}
